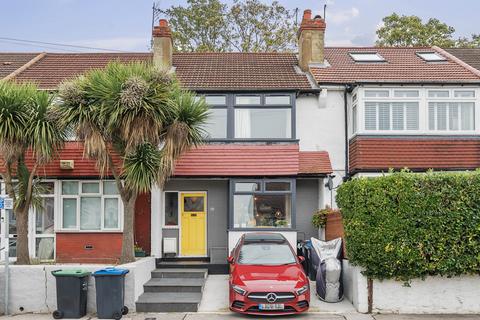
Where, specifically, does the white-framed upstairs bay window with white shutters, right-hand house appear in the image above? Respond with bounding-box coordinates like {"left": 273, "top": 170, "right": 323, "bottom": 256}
{"left": 356, "top": 87, "right": 478, "bottom": 134}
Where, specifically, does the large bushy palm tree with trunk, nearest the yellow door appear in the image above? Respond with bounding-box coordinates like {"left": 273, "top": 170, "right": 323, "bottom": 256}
{"left": 57, "top": 62, "right": 208, "bottom": 263}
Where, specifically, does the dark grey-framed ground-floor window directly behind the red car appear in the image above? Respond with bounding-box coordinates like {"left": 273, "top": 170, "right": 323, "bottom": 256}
{"left": 231, "top": 180, "right": 295, "bottom": 229}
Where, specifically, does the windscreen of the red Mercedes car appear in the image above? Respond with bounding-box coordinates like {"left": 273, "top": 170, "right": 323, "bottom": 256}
{"left": 237, "top": 243, "right": 296, "bottom": 266}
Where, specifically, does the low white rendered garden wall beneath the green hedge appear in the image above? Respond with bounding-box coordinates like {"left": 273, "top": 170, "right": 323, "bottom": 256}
{"left": 343, "top": 260, "right": 480, "bottom": 314}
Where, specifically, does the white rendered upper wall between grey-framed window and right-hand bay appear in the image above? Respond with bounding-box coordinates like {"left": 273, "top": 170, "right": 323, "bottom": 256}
{"left": 296, "top": 91, "right": 345, "bottom": 208}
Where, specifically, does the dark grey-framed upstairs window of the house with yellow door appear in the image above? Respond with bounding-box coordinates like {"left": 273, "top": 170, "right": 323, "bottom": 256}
{"left": 201, "top": 93, "right": 295, "bottom": 140}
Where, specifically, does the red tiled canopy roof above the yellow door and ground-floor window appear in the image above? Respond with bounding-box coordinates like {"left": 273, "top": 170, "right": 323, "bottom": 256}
{"left": 174, "top": 144, "right": 331, "bottom": 176}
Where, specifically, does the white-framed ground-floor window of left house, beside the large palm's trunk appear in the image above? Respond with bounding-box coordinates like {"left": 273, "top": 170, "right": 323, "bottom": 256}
{"left": 59, "top": 180, "right": 123, "bottom": 232}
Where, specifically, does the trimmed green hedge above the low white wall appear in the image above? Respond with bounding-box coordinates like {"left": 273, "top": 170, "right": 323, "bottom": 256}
{"left": 337, "top": 171, "right": 480, "bottom": 281}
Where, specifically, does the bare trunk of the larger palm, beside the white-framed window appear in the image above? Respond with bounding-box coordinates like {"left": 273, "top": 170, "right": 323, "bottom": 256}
{"left": 120, "top": 194, "right": 137, "bottom": 263}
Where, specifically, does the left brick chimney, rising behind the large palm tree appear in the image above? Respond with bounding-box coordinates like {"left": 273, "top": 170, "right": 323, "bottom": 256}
{"left": 152, "top": 19, "right": 173, "bottom": 70}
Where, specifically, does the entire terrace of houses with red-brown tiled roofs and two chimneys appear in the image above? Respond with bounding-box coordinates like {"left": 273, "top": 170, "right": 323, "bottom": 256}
{"left": 0, "top": 10, "right": 480, "bottom": 264}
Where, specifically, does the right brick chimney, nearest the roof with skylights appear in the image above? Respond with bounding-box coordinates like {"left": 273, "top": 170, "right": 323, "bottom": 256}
{"left": 298, "top": 10, "right": 327, "bottom": 71}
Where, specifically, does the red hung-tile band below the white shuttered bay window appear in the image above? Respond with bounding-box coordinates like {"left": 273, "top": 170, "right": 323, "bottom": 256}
{"left": 349, "top": 137, "right": 480, "bottom": 172}
